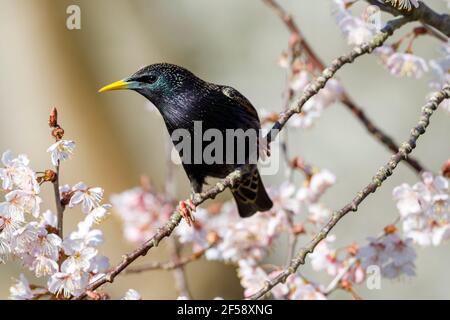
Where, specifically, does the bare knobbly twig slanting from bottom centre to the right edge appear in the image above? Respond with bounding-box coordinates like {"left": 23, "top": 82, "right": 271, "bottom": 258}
{"left": 250, "top": 85, "right": 450, "bottom": 299}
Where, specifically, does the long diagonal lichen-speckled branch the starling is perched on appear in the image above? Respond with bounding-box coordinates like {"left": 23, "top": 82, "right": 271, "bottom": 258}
{"left": 77, "top": 18, "right": 409, "bottom": 299}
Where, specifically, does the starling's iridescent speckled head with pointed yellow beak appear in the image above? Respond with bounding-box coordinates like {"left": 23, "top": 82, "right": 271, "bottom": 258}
{"left": 99, "top": 63, "right": 199, "bottom": 107}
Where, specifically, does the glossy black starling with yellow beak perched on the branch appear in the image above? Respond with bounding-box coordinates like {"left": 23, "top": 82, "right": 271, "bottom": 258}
{"left": 99, "top": 63, "right": 272, "bottom": 223}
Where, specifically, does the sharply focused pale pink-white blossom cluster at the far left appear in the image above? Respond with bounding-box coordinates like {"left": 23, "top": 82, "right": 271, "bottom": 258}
{"left": 0, "top": 119, "right": 118, "bottom": 299}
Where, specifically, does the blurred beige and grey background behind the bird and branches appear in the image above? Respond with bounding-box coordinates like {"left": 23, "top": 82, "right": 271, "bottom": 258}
{"left": 0, "top": 0, "right": 450, "bottom": 299}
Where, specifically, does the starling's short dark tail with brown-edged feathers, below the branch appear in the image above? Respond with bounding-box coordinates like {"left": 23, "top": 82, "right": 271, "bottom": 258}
{"left": 231, "top": 166, "right": 273, "bottom": 218}
